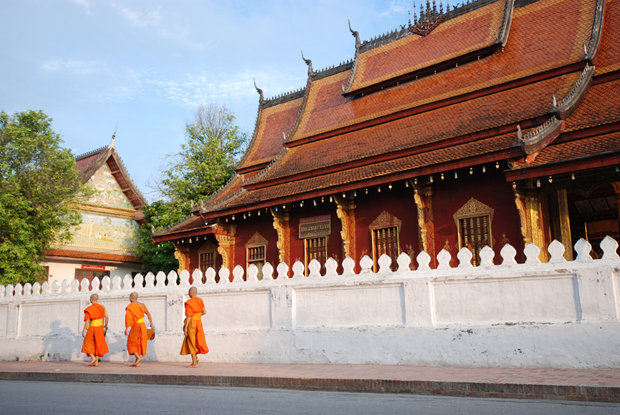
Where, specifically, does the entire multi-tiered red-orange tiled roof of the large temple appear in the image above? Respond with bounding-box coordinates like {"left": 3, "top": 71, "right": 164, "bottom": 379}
{"left": 157, "top": 0, "right": 620, "bottom": 236}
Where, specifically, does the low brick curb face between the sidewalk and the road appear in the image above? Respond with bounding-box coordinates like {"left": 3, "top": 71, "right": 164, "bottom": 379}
{"left": 0, "top": 372, "right": 620, "bottom": 403}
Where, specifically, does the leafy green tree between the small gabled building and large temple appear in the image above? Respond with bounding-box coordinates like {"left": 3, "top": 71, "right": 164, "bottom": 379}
{"left": 137, "top": 104, "right": 247, "bottom": 272}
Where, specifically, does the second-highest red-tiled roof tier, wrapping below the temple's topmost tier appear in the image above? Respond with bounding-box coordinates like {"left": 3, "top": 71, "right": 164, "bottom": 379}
{"left": 290, "top": 0, "right": 600, "bottom": 141}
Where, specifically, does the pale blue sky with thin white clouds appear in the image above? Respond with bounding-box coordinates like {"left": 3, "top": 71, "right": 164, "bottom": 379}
{"left": 0, "top": 0, "right": 419, "bottom": 202}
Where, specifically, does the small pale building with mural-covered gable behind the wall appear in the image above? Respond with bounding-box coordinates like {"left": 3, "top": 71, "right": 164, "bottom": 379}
{"left": 41, "top": 138, "right": 146, "bottom": 281}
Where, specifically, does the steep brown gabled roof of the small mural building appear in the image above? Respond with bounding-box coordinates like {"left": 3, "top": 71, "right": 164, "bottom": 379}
{"left": 75, "top": 137, "right": 147, "bottom": 210}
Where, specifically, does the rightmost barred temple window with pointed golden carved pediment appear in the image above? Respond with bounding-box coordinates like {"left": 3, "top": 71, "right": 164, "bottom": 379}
{"left": 454, "top": 197, "right": 494, "bottom": 266}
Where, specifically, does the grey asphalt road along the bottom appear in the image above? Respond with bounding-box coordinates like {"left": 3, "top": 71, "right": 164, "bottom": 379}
{"left": 0, "top": 381, "right": 620, "bottom": 415}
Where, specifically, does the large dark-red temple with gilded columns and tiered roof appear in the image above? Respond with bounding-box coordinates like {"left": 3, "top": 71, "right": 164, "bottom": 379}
{"left": 153, "top": 0, "right": 620, "bottom": 277}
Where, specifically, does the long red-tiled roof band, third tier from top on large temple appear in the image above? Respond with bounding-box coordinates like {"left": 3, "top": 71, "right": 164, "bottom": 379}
{"left": 255, "top": 73, "right": 580, "bottom": 182}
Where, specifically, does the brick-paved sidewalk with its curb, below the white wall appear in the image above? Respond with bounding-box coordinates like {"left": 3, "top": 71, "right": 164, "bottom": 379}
{"left": 0, "top": 360, "right": 620, "bottom": 402}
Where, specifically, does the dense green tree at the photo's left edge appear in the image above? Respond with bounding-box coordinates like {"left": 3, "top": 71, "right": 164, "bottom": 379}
{"left": 0, "top": 111, "right": 87, "bottom": 284}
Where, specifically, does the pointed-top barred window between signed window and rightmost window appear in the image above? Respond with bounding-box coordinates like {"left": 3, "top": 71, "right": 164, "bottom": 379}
{"left": 370, "top": 210, "right": 402, "bottom": 272}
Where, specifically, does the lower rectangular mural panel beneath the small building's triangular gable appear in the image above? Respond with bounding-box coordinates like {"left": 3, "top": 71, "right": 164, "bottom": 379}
{"left": 70, "top": 213, "right": 138, "bottom": 251}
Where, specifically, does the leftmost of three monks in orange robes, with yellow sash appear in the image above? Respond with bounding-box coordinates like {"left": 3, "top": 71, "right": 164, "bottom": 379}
{"left": 82, "top": 294, "right": 109, "bottom": 366}
